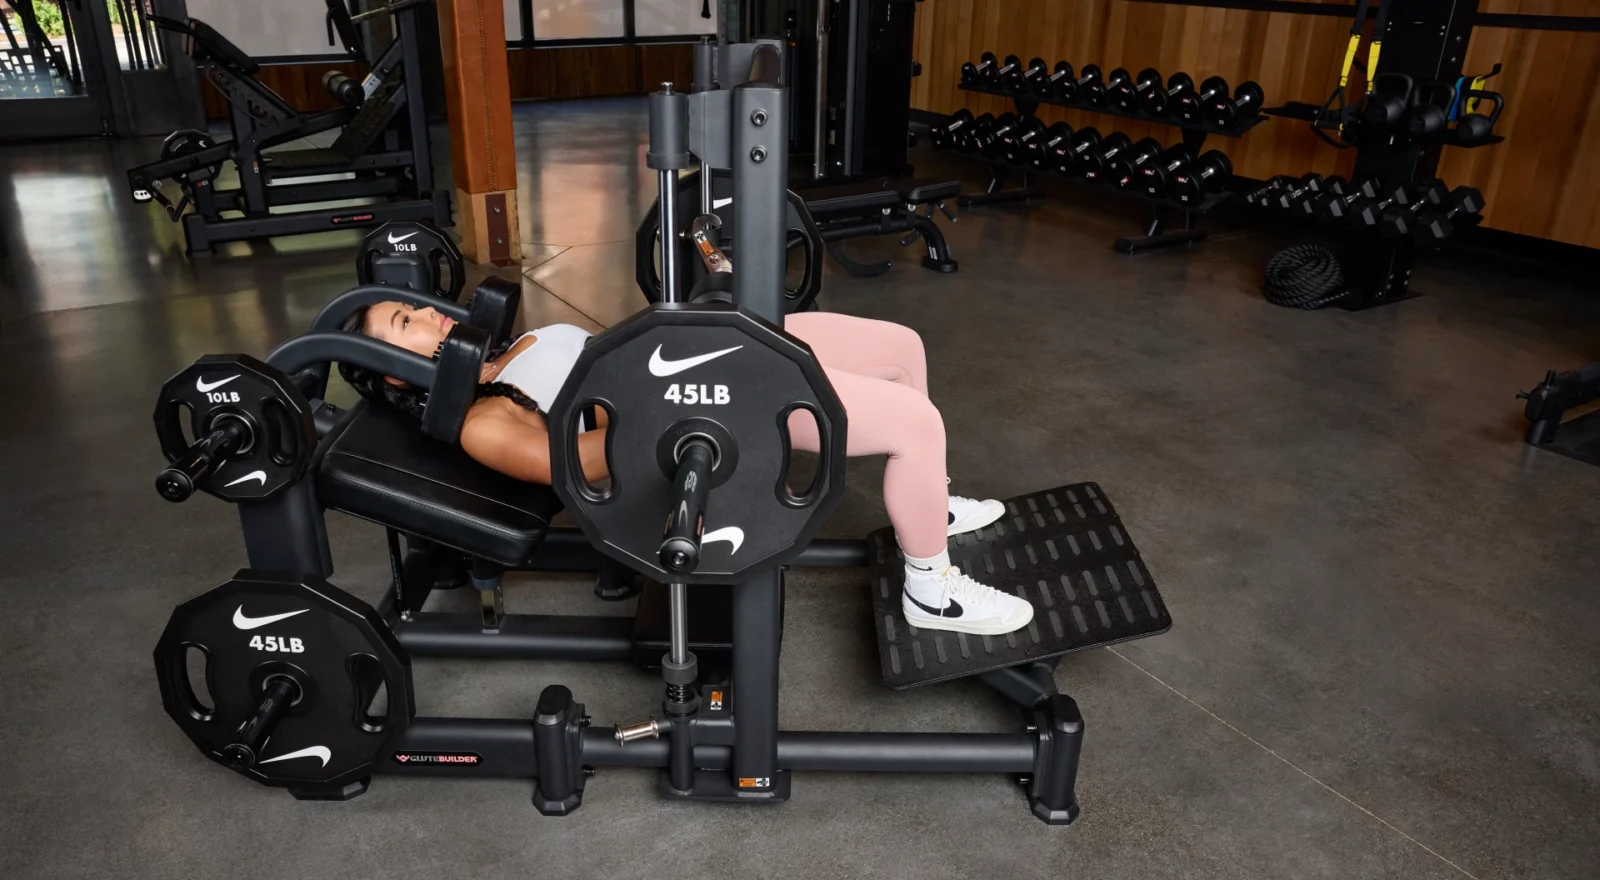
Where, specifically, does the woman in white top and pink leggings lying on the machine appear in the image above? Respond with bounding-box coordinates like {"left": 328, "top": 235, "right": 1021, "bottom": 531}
{"left": 339, "top": 302, "right": 1034, "bottom": 635}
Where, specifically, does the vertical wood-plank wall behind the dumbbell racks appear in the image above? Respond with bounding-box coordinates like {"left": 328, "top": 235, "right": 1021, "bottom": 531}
{"left": 912, "top": 0, "right": 1600, "bottom": 246}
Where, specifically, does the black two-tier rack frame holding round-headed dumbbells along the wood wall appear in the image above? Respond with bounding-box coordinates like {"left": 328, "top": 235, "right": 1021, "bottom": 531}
{"left": 957, "top": 83, "right": 1266, "bottom": 254}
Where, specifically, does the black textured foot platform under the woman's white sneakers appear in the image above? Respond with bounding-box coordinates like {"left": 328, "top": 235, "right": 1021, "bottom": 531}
{"left": 867, "top": 483, "right": 1173, "bottom": 690}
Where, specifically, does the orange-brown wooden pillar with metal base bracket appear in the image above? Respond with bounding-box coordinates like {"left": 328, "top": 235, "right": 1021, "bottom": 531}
{"left": 437, "top": 0, "right": 522, "bottom": 266}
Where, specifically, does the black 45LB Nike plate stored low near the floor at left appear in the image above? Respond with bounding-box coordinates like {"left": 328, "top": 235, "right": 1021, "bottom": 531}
{"left": 155, "top": 570, "right": 414, "bottom": 794}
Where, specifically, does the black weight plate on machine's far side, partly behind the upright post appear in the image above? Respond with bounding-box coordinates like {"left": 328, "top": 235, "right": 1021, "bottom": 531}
{"left": 634, "top": 171, "right": 822, "bottom": 314}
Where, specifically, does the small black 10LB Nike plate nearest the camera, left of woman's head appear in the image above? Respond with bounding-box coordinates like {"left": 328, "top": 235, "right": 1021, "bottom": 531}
{"left": 155, "top": 355, "right": 317, "bottom": 501}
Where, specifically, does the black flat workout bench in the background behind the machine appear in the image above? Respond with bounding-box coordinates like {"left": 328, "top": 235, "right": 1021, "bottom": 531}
{"left": 800, "top": 178, "right": 962, "bottom": 278}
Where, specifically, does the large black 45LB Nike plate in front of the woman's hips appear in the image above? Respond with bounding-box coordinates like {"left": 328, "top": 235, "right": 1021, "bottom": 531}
{"left": 550, "top": 304, "right": 845, "bottom": 584}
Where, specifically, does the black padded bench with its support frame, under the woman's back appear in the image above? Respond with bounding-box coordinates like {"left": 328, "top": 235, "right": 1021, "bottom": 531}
{"left": 314, "top": 400, "right": 733, "bottom": 667}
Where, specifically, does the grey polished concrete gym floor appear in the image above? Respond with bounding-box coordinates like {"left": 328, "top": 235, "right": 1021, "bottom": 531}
{"left": 0, "top": 101, "right": 1600, "bottom": 880}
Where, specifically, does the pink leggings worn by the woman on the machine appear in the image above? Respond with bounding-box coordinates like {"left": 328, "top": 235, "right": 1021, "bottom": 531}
{"left": 784, "top": 312, "right": 949, "bottom": 558}
